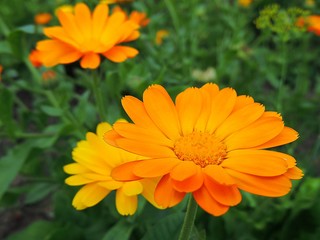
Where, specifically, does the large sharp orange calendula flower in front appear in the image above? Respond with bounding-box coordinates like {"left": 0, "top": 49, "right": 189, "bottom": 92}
{"left": 105, "top": 83, "right": 303, "bottom": 216}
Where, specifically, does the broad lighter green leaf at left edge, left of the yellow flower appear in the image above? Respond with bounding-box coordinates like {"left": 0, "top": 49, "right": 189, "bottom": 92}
{"left": 0, "top": 142, "right": 34, "bottom": 199}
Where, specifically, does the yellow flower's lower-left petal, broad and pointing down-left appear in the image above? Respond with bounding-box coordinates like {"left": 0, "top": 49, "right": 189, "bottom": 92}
{"left": 72, "top": 183, "right": 110, "bottom": 210}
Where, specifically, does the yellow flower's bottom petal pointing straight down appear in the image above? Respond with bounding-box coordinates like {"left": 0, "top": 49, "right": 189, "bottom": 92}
{"left": 116, "top": 188, "right": 138, "bottom": 216}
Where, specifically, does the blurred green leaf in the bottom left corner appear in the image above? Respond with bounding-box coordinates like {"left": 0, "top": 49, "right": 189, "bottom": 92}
{"left": 6, "top": 220, "right": 55, "bottom": 240}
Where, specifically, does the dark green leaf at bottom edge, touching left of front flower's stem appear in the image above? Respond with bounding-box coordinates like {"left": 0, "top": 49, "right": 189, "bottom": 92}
{"left": 142, "top": 212, "right": 184, "bottom": 240}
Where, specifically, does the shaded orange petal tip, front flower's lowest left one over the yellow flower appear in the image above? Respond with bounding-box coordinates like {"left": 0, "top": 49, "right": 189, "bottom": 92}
{"left": 111, "top": 161, "right": 141, "bottom": 181}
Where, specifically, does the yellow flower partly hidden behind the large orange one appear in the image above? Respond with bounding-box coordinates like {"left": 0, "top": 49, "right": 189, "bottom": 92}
{"left": 64, "top": 122, "right": 157, "bottom": 215}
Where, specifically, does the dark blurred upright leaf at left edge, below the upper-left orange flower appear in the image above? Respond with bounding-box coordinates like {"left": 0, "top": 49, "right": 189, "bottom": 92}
{"left": 0, "top": 86, "right": 16, "bottom": 137}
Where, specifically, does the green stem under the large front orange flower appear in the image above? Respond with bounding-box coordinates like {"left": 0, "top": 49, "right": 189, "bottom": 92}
{"left": 179, "top": 195, "right": 198, "bottom": 240}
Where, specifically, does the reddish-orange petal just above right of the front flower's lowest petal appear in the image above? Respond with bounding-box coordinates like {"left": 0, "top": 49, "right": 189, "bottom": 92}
{"left": 204, "top": 175, "right": 242, "bottom": 206}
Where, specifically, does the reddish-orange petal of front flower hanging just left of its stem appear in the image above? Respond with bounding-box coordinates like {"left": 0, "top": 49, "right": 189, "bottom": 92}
{"left": 154, "top": 174, "right": 185, "bottom": 208}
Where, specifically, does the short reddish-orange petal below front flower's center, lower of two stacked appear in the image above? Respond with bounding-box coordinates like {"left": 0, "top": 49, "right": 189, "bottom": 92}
{"left": 172, "top": 166, "right": 203, "bottom": 192}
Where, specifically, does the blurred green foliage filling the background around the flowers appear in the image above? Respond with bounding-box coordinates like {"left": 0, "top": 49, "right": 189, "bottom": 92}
{"left": 0, "top": 0, "right": 320, "bottom": 240}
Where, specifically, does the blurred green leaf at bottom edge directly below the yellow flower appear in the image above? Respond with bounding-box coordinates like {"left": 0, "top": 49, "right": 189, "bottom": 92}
{"left": 102, "top": 220, "right": 134, "bottom": 240}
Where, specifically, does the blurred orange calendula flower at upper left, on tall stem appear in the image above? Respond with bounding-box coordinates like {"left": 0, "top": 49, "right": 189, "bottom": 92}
{"left": 37, "top": 3, "right": 139, "bottom": 69}
